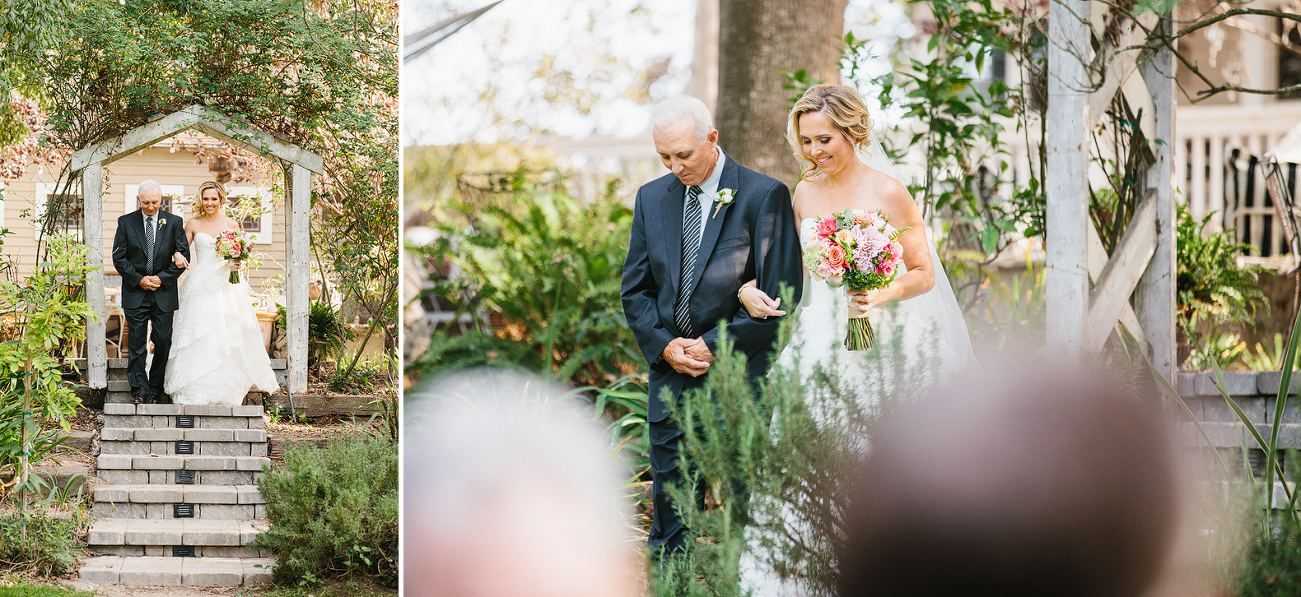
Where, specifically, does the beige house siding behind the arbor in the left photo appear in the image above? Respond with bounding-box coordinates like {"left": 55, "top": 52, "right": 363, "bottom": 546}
{"left": 0, "top": 143, "right": 286, "bottom": 294}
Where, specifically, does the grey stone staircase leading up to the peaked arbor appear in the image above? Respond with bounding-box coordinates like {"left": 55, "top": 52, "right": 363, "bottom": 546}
{"left": 79, "top": 359, "right": 275, "bottom": 587}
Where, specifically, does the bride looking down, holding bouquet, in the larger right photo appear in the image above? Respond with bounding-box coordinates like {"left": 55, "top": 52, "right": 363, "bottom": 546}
{"left": 739, "top": 85, "right": 974, "bottom": 597}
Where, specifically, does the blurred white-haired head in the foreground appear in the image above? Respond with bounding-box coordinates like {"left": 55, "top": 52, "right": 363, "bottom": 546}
{"left": 402, "top": 371, "right": 640, "bottom": 597}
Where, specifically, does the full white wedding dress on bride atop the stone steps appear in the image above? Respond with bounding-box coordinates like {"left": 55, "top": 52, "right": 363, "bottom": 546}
{"left": 163, "top": 233, "right": 280, "bottom": 406}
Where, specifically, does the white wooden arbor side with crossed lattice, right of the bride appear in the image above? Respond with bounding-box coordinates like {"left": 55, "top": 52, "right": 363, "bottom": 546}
{"left": 1046, "top": 0, "right": 1177, "bottom": 382}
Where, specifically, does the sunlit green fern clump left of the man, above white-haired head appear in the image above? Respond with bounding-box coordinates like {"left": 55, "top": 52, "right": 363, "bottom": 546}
{"left": 407, "top": 186, "right": 644, "bottom": 386}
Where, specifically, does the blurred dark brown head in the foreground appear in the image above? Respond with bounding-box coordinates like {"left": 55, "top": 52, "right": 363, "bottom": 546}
{"left": 838, "top": 363, "right": 1180, "bottom": 597}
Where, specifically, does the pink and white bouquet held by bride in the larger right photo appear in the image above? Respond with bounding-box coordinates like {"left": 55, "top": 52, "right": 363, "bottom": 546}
{"left": 804, "top": 209, "right": 908, "bottom": 350}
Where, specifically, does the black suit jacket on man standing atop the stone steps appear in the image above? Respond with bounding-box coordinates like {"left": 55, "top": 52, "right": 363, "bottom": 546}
{"left": 113, "top": 209, "right": 190, "bottom": 311}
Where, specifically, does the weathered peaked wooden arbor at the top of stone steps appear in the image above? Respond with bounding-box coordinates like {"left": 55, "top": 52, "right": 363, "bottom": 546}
{"left": 72, "top": 105, "right": 324, "bottom": 391}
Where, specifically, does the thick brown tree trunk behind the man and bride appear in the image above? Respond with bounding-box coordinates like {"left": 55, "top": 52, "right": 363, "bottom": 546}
{"left": 718, "top": 0, "right": 848, "bottom": 185}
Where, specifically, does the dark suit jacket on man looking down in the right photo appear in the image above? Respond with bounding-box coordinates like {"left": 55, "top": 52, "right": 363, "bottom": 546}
{"left": 621, "top": 156, "right": 804, "bottom": 421}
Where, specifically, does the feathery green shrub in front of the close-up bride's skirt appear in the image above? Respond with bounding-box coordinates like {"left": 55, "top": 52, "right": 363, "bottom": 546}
{"left": 651, "top": 305, "right": 935, "bottom": 597}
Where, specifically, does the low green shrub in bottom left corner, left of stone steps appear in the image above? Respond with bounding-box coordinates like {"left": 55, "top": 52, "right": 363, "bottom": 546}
{"left": 0, "top": 510, "right": 87, "bottom": 576}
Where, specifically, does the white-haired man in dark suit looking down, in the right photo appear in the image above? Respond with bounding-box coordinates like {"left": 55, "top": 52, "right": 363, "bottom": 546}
{"left": 621, "top": 98, "right": 803, "bottom": 551}
